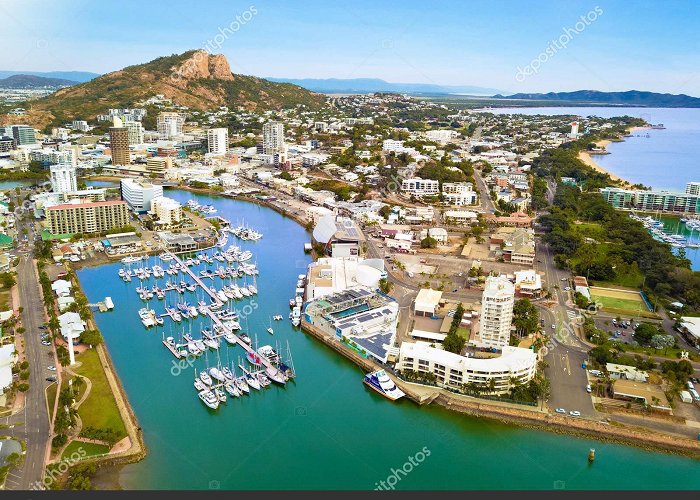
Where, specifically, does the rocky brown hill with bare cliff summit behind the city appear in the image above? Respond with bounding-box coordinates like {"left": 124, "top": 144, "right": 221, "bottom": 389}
{"left": 31, "top": 50, "right": 325, "bottom": 123}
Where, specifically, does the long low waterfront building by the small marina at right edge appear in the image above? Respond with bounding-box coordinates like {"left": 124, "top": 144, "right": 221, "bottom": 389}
{"left": 600, "top": 185, "right": 700, "bottom": 214}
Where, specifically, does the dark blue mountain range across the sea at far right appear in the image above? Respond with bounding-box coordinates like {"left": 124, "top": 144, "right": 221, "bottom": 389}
{"left": 493, "top": 90, "right": 700, "bottom": 108}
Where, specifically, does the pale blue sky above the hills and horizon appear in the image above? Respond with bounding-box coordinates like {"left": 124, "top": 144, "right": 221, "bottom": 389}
{"left": 0, "top": 0, "right": 700, "bottom": 96}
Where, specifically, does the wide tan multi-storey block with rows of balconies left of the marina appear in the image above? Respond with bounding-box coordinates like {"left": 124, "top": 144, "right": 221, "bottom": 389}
{"left": 46, "top": 200, "right": 129, "bottom": 234}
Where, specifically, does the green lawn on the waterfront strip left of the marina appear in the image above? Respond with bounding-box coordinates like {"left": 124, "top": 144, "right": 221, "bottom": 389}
{"left": 74, "top": 349, "right": 126, "bottom": 439}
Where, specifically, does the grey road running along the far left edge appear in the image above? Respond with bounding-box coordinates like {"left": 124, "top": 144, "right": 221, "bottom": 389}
{"left": 2, "top": 202, "right": 54, "bottom": 490}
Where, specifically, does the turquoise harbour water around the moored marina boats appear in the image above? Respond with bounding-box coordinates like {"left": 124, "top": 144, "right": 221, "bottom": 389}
{"left": 78, "top": 191, "right": 700, "bottom": 489}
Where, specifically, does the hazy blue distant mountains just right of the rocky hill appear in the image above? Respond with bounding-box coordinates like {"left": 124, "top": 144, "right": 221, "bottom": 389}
{"left": 266, "top": 78, "right": 500, "bottom": 96}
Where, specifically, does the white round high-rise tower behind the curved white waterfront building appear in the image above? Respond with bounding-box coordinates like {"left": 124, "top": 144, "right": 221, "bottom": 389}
{"left": 479, "top": 276, "right": 515, "bottom": 349}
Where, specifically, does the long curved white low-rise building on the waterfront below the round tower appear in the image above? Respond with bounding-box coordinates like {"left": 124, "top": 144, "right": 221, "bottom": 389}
{"left": 396, "top": 342, "right": 537, "bottom": 394}
